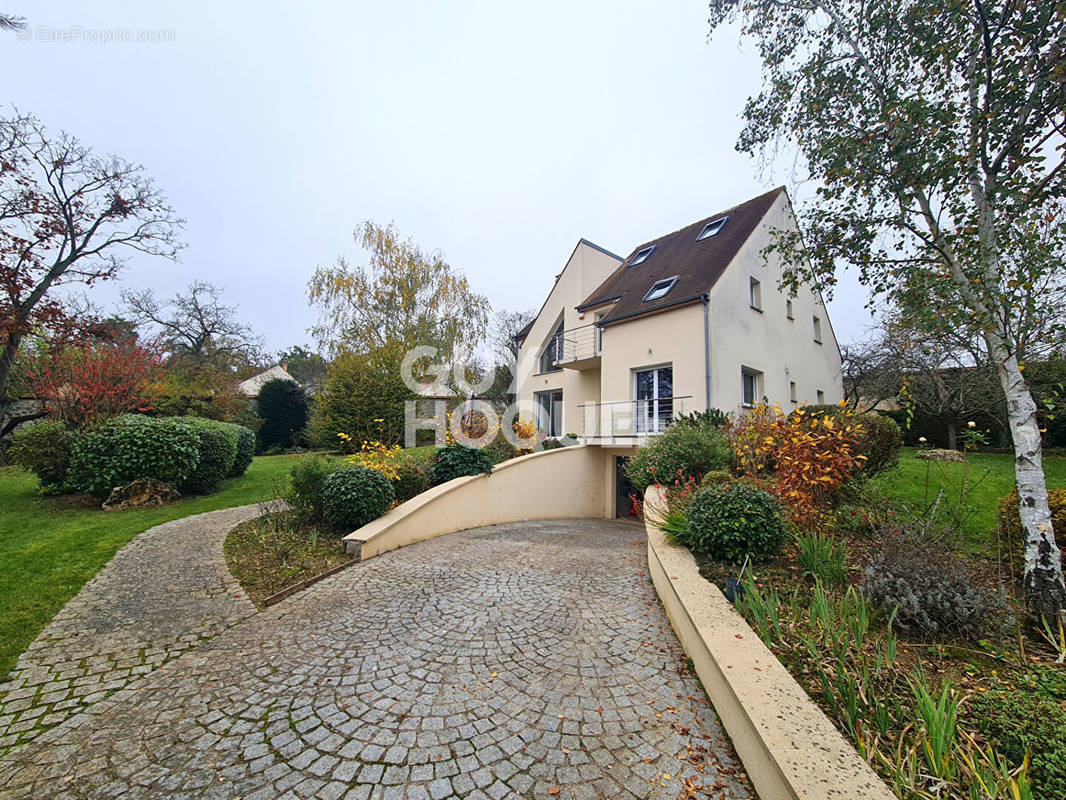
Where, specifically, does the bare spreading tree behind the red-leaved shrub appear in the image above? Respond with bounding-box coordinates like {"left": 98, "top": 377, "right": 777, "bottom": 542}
{"left": 123, "top": 281, "right": 262, "bottom": 366}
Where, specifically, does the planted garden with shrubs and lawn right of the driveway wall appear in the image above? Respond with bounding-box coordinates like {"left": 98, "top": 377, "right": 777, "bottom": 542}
{"left": 627, "top": 406, "right": 1066, "bottom": 800}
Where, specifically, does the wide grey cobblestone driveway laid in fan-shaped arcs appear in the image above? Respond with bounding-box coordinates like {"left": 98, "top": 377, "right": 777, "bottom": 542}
{"left": 0, "top": 521, "right": 749, "bottom": 800}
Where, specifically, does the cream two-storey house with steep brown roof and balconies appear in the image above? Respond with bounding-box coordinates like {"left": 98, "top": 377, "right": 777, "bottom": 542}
{"left": 516, "top": 188, "right": 842, "bottom": 509}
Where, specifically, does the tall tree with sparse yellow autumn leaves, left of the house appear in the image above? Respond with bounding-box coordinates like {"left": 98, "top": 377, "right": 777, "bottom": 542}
{"left": 307, "top": 221, "right": 488, "bottom": 359}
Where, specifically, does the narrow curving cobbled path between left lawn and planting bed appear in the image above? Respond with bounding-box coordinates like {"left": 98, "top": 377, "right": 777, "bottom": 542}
{"left": 0, "top": 505, "right": 261, "bottom": 753}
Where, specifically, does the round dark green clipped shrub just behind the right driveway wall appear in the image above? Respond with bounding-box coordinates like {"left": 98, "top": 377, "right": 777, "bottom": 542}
{"left": 685, "top": 482, "right": 786, "bottom": 562}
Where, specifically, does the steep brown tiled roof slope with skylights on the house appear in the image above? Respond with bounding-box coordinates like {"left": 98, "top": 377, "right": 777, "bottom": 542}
{"left": 578, "top": 187, "right": 785, "bottom": 325}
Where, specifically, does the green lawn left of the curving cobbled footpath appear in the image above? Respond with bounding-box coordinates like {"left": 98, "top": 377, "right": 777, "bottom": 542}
{"left": 0, "top": 455, "right": 340, "bottom": 677}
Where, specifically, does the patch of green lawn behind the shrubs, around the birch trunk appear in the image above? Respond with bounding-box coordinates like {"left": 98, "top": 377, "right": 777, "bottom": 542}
{"left": 874, "top": 448, "right": 1066, "bottom": 548}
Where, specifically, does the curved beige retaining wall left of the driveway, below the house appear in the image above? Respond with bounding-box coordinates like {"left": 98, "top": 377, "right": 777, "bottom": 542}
{"left": 344, "top": 445, "right": 605, "bottom": 561}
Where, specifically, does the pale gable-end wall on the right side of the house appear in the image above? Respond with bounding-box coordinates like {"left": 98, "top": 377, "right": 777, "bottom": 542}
{"left": 710, "top": 192, "right": 843, "bottom": 412}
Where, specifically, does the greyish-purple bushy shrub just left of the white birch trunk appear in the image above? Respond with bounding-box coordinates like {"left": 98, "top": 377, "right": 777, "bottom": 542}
{"left": 861, "top": 530, "right": 1003, "bottom": 640}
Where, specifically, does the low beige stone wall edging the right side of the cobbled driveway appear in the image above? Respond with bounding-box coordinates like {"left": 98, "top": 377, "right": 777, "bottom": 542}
{"left": 645, "top": 487, "right": 895, "bottom": 800}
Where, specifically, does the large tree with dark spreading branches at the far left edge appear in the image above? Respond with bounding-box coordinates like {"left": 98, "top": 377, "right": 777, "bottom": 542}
{"left": 0, "top": 115, "right": 182, "bottom": 426}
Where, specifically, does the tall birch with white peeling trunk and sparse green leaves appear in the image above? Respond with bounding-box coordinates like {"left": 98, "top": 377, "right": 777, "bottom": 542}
{"left": 710, "top": 0, "right": 1066, "bottom": 618}
